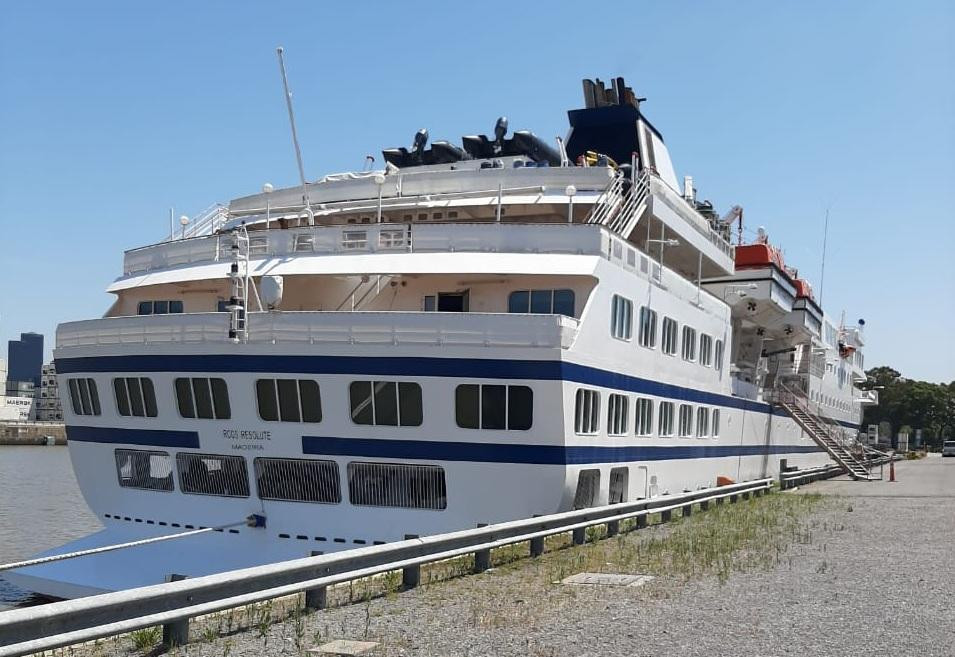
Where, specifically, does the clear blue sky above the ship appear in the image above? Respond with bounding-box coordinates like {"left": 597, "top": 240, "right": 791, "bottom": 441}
{"left": 0, "top": 0, "right": 955, "bottom": 381}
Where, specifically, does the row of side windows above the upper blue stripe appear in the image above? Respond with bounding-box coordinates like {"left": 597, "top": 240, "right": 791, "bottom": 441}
{"left": 610, "top": 294, "right": 723, "bottom": 371}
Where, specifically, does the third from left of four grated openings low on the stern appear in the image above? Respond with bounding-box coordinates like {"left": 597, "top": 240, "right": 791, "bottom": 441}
{"left": 253, "top": 458, "right": 342, "bottom": 504}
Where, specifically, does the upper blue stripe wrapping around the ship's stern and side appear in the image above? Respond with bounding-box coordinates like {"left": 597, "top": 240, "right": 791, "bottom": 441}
{"left": 56, "top": 354, "right": 859, "bottom": 429}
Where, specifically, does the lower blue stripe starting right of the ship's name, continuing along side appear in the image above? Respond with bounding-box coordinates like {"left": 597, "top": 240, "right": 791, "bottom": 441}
{"left": 302, "top": 436, "right": 822, "bottom": 465}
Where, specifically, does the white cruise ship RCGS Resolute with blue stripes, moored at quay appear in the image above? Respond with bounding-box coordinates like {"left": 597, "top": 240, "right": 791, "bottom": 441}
{"left": 5, "top": 78, "right": 875, "bottom": 597}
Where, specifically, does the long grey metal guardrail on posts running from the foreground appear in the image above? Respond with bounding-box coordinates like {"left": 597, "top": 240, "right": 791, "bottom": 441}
{"left": 0, "top": 478, "right": 772, "bottom": 657}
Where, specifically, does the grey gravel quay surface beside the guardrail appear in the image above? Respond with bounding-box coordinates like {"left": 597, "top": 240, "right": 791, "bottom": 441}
{"left": 69, "top": 459, "right": 955, "bottom": 657}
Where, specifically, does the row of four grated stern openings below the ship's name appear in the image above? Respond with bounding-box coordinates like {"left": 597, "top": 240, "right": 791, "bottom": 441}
{"left": 115, "top": 449, "right": 447, "bottom": 509}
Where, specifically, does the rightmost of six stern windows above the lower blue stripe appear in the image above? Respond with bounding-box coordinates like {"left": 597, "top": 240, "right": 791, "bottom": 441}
{"left": 454, "top": 384, "right": 534, "bottom": 431}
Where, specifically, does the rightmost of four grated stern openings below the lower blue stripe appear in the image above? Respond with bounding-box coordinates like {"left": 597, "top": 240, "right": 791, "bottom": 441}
{"left": 348, "top": 461, "right": 448, "bottom": 510}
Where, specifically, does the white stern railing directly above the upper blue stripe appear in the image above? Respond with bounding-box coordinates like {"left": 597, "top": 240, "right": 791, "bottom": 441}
{"left": 56, "top": 311, "right": 578, "bottom": 349}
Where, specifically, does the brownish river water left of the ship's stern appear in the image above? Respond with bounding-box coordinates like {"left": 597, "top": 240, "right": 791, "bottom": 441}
{"left": 0, "top": 446, "right": 102, "bottom": 609}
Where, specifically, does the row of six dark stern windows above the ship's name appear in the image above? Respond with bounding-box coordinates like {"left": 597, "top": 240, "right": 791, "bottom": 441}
{"left": 69, "top": 377, "right": 534, "bottom": 431}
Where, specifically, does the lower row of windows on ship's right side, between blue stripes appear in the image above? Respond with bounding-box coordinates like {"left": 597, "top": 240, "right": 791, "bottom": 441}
{"left": 574, "top": 388, "right": 720, "bottom": 438}
